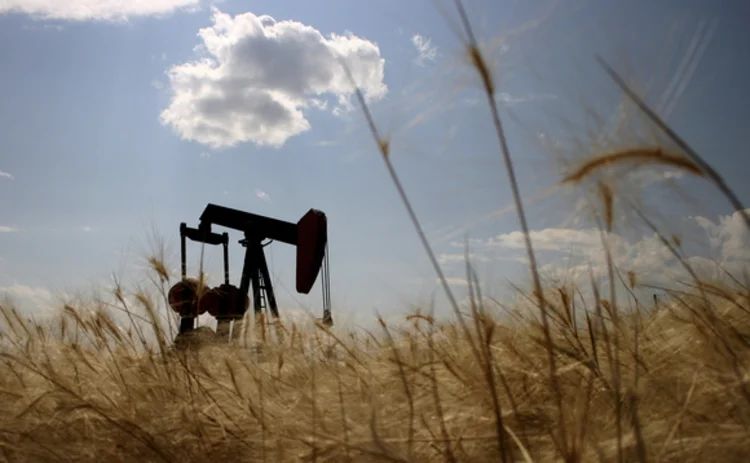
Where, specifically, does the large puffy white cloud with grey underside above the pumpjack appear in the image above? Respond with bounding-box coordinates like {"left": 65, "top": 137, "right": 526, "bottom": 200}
{"left": 160, "top": 9, "right": 387, "bottom": 149}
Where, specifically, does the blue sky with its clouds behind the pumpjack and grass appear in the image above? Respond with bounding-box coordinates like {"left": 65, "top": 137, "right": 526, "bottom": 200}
{"left": 0, "top": 0, "right": 750, "bottom": 326}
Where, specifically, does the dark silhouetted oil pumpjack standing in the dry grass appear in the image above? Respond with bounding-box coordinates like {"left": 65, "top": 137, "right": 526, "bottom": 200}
{"left": 168, "top": 204, "right": 333, "bottom": 339}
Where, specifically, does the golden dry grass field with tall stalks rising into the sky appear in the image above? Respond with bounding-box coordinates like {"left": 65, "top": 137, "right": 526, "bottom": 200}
{"left": 0, "top": 2, "right": 750, "bottom": 462}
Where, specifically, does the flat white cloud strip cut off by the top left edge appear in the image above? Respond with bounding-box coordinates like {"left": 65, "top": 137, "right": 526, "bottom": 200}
{"left": 0, "top": 0, "right": 200, "bottom": 21}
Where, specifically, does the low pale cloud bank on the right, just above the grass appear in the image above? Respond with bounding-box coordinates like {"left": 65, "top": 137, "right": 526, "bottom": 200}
{"left": 439, "top": 210, "right": 750, "bottom": 298}
